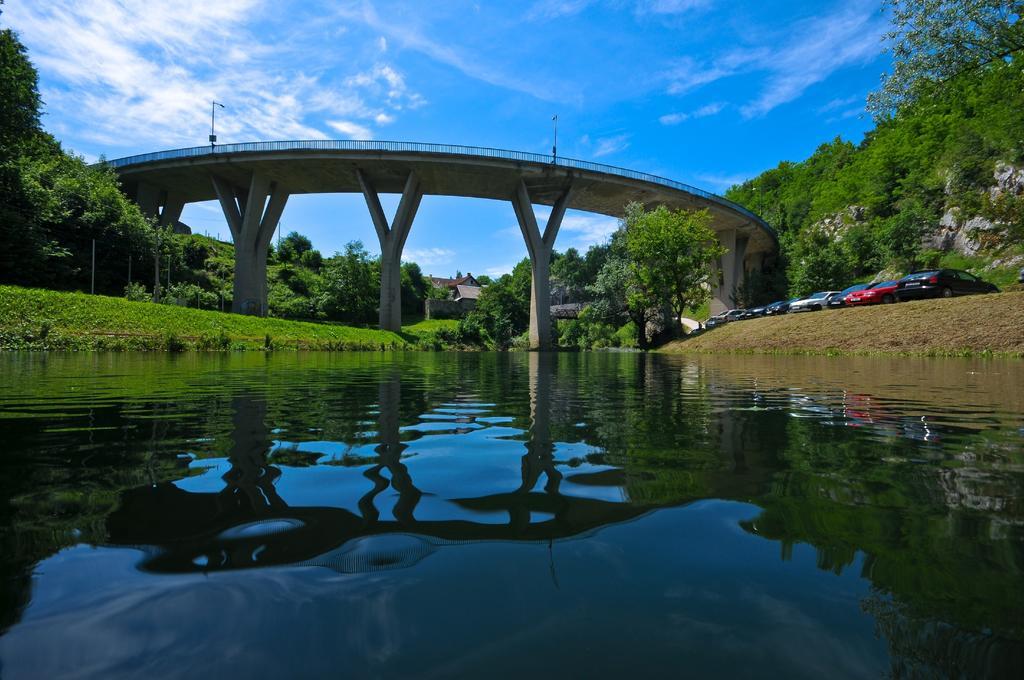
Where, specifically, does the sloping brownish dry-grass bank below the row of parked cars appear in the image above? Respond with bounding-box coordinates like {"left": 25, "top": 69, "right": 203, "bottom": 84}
{"left": 663, "top": 292, "right": 1024, "bottom": 356}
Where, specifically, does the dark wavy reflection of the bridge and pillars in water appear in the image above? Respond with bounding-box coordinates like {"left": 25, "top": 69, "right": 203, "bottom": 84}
{"left": 108, "top": 353, "right": 663, "bottom": 571}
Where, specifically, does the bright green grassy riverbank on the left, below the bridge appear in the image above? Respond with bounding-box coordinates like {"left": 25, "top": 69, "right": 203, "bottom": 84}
{"left": 0, "top": 286, "right": 453, "bottom": 351}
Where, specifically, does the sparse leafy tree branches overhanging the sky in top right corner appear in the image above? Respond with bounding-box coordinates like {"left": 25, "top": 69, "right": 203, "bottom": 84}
{"left": 867, "top": 0, "right": 1024, "bottom": 117}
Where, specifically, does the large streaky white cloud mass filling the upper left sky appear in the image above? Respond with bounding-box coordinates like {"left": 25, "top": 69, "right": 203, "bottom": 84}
{"left": 4, "top": 0, "right": 422, "bottom": 146}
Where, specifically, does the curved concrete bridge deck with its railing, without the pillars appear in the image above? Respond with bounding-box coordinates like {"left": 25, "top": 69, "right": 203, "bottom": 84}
{"left": 109, "top": 140, "right": 776, "bottom": 252}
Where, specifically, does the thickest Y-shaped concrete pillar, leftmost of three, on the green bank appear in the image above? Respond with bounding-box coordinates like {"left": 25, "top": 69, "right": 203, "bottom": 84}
{"left": 212, "top": 172, "right": 288, "bottom": 316}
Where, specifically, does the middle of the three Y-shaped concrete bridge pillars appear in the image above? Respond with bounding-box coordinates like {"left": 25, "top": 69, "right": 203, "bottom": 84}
{"left": 355, "top": 169, "right": 423, "bottom": 333}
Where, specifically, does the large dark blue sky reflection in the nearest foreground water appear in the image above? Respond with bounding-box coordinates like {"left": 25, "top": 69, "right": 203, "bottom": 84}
{"left": 0, "top": 502, "right": 887, "bottom": 678}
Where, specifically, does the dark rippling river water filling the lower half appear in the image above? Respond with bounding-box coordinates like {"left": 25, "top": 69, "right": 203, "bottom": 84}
{"left": 0, "top": 353, "right": 1024, "bottom": 678}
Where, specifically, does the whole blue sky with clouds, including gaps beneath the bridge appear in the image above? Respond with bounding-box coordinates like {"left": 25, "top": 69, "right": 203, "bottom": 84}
{"left": 6, "top": 0, "right": 888, "bottom": 274}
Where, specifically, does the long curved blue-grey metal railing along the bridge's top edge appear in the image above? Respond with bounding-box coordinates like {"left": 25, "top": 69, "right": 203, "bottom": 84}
{"left": 106, "top": 139, "right": 774, "bottom": 235}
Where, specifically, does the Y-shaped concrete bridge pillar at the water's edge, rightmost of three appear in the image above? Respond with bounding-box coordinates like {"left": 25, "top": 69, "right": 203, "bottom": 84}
{"left": 512, "top": 179, "right": 572, "bottom": 349}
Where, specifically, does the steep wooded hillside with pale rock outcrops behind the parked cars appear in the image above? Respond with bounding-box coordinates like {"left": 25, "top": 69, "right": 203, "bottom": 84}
{"left": 726, "top": 58, "right": 1024, "bottom": 306}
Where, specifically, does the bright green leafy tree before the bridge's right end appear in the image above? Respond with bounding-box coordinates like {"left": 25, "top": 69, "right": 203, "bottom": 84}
{"left": 626, "top": 204, "right": 726, "bottom": 333}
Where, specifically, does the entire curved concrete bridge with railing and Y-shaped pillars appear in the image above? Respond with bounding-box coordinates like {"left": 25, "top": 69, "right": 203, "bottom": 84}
{"left": 110, "top": 140, "right": 777, "bottom": 348}
